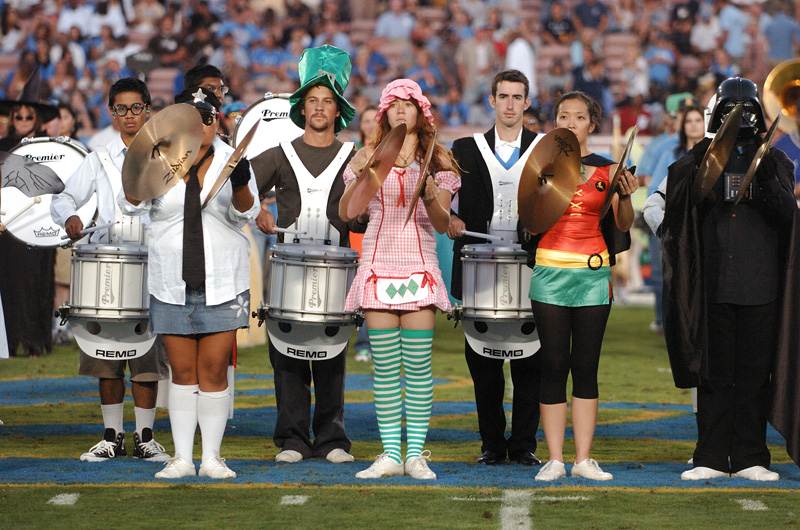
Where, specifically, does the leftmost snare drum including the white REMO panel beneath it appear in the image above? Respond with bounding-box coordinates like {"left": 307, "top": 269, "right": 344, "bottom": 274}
{"left": 59, "top": 245, "right": 156, "bottom": 359}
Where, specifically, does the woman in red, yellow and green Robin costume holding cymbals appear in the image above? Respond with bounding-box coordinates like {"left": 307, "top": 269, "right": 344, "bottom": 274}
{"left": 530, "top": 92, "right": 638, "bottom": 481}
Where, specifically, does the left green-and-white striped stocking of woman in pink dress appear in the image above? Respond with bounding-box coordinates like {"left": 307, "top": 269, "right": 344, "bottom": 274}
{"left": 368, "top": 328, "right": 403, "bottom": 464}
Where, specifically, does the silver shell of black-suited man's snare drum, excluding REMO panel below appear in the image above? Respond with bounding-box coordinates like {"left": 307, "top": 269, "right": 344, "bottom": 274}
{"left": 461, "top": 244, "right": 533, "bottom": 320}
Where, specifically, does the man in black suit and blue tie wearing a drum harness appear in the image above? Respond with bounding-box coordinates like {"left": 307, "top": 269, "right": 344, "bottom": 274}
{"left": 447, "top": 70, "right": 542, "bottom": 466}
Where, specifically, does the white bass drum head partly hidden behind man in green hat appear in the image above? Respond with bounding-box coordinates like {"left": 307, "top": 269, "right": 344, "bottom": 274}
{"left": 233, "top": 93, "right": 303, "bottom": 160}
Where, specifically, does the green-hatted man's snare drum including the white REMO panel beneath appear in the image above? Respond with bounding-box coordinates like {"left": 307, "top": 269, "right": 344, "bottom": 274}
{"left": 259, "top": 243, "right": 358, "bottom": 360}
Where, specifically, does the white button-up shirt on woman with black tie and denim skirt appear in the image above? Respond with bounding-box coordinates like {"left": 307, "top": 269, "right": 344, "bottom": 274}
{"left": 117, "top": 138, "right": 260, "bottom": 305}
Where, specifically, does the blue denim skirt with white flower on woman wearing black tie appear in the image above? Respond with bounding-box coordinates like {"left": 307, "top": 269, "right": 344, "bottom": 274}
{"left": 150, "top": 287, "right": 250, "bottom": 335}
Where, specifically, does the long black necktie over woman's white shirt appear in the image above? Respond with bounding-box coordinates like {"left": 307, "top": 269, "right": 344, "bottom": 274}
{"left": 183, "top": 148, "right": 214, "bottom": 290}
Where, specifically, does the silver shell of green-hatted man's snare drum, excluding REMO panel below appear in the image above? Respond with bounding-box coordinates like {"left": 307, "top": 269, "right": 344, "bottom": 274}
{"left": 267, "top": 243, "right": 358, "bottom": 326}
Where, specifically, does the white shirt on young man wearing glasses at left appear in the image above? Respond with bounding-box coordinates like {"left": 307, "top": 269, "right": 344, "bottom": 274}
{"left": 50, "top": 133, "right": 144, "bottom": 244}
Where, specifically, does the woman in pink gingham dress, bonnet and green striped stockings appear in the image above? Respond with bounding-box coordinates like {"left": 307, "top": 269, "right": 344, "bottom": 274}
{"left": 340, "top": 79, "right": 461, "bottom": 479}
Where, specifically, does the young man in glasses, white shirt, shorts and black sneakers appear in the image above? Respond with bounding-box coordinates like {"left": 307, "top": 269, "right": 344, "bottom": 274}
{"left": 50, "top": 77, "right": 169, "bottom": 462}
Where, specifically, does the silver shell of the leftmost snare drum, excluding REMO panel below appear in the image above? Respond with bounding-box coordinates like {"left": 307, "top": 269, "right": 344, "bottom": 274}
{"left": 69, "top": 245, "right": 150, "bottom": 320}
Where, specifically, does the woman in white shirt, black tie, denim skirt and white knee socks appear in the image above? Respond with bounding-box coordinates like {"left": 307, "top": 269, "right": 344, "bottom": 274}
{"left": 118, "top": 88, "right": 258, "bottom": 479}
